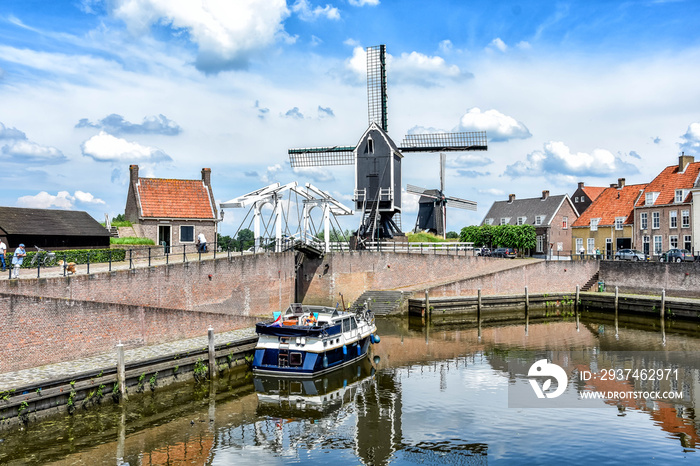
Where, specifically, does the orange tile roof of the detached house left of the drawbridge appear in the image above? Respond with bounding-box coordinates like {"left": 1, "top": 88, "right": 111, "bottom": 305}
{"left": 137, "top": 178, "right": 216, "bottom": 219}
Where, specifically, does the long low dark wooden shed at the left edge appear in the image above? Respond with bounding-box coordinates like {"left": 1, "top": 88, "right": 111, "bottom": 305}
{"left": 0, "top": 207, "right": 109, "bottom": 250}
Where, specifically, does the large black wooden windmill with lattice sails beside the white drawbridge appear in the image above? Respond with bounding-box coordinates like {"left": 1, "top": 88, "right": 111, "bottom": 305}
{"left": 288, "top": 45, "right": 487, "bottom": 244}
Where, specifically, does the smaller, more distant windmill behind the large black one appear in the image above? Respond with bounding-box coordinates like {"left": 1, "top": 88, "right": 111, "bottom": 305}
{"left": 406, "top": 152, "right": 476, "bottom": 238}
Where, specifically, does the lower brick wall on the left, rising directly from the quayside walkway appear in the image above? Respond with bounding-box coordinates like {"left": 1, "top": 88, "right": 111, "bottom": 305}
{"left": 0, "top": 294, "right": 256, "bottom": 373}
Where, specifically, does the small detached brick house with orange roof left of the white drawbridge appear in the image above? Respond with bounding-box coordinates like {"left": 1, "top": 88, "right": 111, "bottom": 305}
{"left": 124, "top": 165, "right": 218, "bottom": 250}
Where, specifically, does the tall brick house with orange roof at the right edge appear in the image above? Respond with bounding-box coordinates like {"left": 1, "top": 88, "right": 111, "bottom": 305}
{"left": 634, "top": 155, "right": 700, "bottom": 256}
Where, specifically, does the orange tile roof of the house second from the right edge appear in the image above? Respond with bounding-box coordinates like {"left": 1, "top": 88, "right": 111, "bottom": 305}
{"left": 572, "top": 184, "right": 647, "bottom": 227}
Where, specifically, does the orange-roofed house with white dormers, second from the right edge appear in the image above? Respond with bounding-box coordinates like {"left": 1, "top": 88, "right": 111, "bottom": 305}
{"left": 572, "top": 178, "right": 647, "bottom": 258}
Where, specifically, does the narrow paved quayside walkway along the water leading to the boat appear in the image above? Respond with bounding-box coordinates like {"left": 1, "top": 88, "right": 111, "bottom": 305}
{"left": 0, "top": 327, "right": 255, "bottom": 391}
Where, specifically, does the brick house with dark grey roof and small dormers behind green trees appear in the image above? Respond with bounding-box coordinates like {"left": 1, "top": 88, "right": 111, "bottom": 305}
{"left": 481, "top": 191, "right": 578, "bottom": 257}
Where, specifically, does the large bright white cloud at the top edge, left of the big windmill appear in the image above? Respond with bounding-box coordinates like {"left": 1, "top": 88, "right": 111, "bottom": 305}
{"left": 108, "top": 0, "right": 289, "bottom": 73}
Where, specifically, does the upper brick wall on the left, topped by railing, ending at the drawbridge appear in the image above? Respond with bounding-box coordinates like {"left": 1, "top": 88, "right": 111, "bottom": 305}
{"left": 0, "top": 253, "right": 294, "bottom": 316}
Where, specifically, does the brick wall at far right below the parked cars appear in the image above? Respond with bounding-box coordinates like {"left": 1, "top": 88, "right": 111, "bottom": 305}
{"left": 600, "top": 261, "right": 700, "bottom": 298}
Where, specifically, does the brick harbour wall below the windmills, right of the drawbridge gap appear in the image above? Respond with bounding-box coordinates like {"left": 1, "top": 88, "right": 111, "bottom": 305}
{"left": 299, "top": 252, "right": 597, "bottom": 306}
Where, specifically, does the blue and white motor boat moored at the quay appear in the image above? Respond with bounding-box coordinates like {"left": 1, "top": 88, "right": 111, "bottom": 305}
{"left": 253, "top": 304, "right": 379, "bottom": 377}
